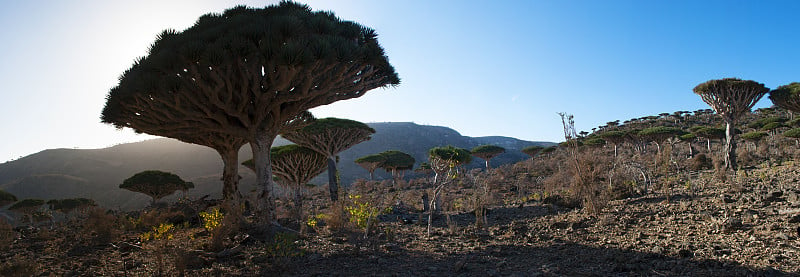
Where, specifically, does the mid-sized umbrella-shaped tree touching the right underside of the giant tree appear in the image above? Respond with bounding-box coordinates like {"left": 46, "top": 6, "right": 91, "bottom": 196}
{"left": 282, "top": 117, "right": 375, "bottom": 202}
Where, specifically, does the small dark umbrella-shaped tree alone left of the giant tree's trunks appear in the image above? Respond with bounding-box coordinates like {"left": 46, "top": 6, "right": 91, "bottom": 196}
{"left": 119, "top": 170, "right": 194, "bottom": 205}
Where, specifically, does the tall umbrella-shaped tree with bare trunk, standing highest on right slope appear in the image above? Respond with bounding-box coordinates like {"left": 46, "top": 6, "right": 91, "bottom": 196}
{"left": 694, "top": 78, "right": 769, "bottom": 170}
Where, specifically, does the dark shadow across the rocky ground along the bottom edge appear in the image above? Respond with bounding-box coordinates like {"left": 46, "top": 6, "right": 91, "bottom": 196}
{"left": 278, "top": 238, "right": 798, "bottom": 276}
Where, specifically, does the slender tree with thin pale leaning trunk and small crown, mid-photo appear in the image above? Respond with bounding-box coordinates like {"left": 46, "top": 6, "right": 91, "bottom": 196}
{"left": 428, "top": 146, "right": 472, "bottom": 236}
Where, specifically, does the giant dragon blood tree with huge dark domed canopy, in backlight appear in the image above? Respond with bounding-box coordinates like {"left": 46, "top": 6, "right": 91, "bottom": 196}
{"left": 102, "top": 1, "right": 400, "bottom": 222}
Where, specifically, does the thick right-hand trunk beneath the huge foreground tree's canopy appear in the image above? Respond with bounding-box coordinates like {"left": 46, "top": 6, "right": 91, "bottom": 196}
{"left": 250, "top": 135, "right": 275, "bottom": 227}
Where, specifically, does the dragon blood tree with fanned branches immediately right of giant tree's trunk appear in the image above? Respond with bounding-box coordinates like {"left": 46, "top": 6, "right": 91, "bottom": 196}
{"left": 243, "top": 144, "right": 327, "bottom": 220}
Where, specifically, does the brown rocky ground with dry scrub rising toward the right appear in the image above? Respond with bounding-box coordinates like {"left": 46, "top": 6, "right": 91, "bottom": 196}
{"left": 0, "top": 163, "right": 800, "bottom": 276}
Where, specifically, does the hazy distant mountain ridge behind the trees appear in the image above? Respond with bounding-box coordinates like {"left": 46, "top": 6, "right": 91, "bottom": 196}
{"left": 0, "top": 122, "right": 553, "bottom": 210}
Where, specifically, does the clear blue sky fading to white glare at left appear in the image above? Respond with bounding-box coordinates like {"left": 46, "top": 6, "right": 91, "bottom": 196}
{"left": 0, "top": 0, "right": 800, "bottom": 162}
